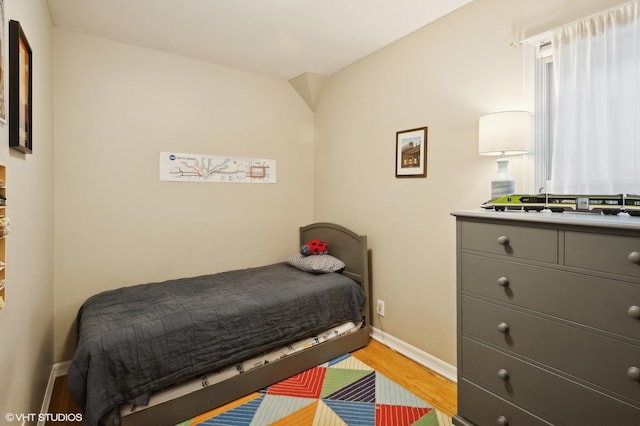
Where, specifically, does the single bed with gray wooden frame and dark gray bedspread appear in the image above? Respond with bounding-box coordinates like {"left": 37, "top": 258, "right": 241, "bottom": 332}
{"left": 68, "top": 223, "right": 371, "bottom": 425}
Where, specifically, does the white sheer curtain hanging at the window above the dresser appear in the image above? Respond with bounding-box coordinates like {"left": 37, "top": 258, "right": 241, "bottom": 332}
{"left": 550, "top": 2, "right": 640, "bottom": 194}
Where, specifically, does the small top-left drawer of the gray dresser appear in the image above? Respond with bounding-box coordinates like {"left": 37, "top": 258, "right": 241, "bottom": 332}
{"left": 461, "top": 222, "right": 558, "bottom": 263}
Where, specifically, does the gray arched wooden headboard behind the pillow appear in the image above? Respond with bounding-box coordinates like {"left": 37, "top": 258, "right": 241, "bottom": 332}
{"left": 300, "top": 222, "right": 371, "bottom": 318}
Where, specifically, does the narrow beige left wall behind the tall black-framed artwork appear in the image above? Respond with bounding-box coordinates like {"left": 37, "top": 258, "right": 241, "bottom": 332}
{"left": 0, "top": 0, "right": 54, "bottom": 423}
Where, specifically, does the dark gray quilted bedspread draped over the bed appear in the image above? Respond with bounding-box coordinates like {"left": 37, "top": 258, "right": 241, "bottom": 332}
{"left": 68, "top": 263, "right": 365, "bottom": 425}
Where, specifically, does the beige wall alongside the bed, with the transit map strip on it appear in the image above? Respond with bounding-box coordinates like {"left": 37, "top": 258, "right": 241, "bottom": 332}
{"left": 54, "top": 29, "right": 313, "bottom": 360}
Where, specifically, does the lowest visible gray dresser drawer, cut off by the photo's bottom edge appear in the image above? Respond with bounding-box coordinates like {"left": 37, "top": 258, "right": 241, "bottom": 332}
{"left": 458, "top": 380, "right": 551, "bottom": 426}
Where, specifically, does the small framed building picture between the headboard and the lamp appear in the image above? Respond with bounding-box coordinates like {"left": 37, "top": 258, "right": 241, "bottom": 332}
{"left": 396, "top": 127, "right": 427, "bottom": 177}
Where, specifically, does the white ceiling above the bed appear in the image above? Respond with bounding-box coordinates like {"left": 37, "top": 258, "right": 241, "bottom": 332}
{"left": 48, "top": 0, "right": 472, "bottom": 79}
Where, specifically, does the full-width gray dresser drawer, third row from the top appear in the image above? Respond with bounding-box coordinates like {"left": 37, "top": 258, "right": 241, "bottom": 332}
{"left": 462, "top": 296, "right": 640, "bottom": 401}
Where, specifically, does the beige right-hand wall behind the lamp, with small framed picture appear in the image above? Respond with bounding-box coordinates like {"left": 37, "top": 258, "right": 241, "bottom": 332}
{"left": 314, "top": 0, "right": 623, "bottom": 365}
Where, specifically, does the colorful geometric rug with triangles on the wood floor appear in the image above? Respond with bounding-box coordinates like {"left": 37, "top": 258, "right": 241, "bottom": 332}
{"left": 180, "top": 354, "right": 452, "bottom": 426}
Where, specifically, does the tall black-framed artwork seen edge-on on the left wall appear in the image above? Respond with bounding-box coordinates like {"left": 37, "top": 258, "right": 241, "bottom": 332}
{"left": 9, "top": 20, "right": 33, "bottom": 154}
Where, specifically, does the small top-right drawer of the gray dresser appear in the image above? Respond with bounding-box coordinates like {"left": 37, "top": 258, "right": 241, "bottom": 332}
{"left": 565, "top": 231, "right": 640, "bottom": 278}
